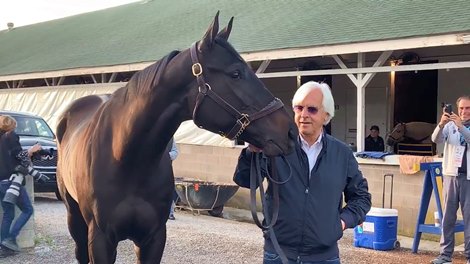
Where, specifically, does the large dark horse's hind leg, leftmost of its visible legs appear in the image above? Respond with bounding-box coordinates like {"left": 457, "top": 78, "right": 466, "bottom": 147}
{"left": 64, "top": 192, "right": 89, "bottom": 264}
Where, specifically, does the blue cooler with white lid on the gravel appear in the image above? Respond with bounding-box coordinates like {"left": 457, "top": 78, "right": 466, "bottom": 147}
{"left": 354, "top": 207, "right": 400, "bottom": 250}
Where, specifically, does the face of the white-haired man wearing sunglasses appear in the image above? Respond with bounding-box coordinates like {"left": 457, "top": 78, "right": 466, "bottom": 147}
{"left": 293, "top": 89, "right": 328, "bottom": 140}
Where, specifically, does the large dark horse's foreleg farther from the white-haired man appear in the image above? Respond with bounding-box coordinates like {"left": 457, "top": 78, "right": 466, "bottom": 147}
{"left": 88, "top": 221, "right": 118, "bottom": 264}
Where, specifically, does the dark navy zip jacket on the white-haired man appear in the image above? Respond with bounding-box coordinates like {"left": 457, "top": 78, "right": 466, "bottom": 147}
{"left": 234, "top": 134, "right": 371, "bottom": 261}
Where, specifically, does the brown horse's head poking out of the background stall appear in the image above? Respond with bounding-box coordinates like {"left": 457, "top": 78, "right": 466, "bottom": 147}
{"left": 387, "top": 122, "right": 436, "bottom": 147}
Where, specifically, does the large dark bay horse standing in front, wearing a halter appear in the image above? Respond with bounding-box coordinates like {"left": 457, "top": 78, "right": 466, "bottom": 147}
{"left": 57, "top": 14, "right": 295, "bottom": 264}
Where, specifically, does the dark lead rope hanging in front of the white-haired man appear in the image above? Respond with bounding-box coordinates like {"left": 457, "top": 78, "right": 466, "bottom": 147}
{"left": 250, "top": 153, "right": 292, "bottom": 264}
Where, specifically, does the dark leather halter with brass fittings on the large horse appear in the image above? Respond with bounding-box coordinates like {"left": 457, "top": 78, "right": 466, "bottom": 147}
{"left": 190, "top": 42, "right": 284, "bottom": 139}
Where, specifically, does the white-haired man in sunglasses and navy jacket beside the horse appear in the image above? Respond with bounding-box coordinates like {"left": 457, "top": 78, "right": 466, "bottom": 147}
{"left": 234, "top": 82, "right": 371, "bottom": 264}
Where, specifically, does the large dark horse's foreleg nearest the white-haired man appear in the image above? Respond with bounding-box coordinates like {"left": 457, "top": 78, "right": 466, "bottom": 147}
{"left": 135, "top": 225, "right": 166, "bottom": 264}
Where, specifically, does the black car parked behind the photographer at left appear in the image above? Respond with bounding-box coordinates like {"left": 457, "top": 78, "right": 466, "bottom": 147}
{"left": 0, "top": 111, "right": 61, "bottom": 200}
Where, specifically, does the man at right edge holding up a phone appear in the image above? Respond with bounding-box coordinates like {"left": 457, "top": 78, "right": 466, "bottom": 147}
{"left": 431, "top": 95, "right": 470, "bottom": 264}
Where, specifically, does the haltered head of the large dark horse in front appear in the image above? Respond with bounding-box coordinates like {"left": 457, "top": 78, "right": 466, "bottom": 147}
{"left": 188, "top": 13, "right": 294, "bottom": 156}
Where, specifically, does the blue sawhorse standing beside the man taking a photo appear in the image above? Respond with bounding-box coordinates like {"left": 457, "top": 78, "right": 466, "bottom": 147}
{"left": 411, "top": 162, "right": 464, "bottom": 253}
